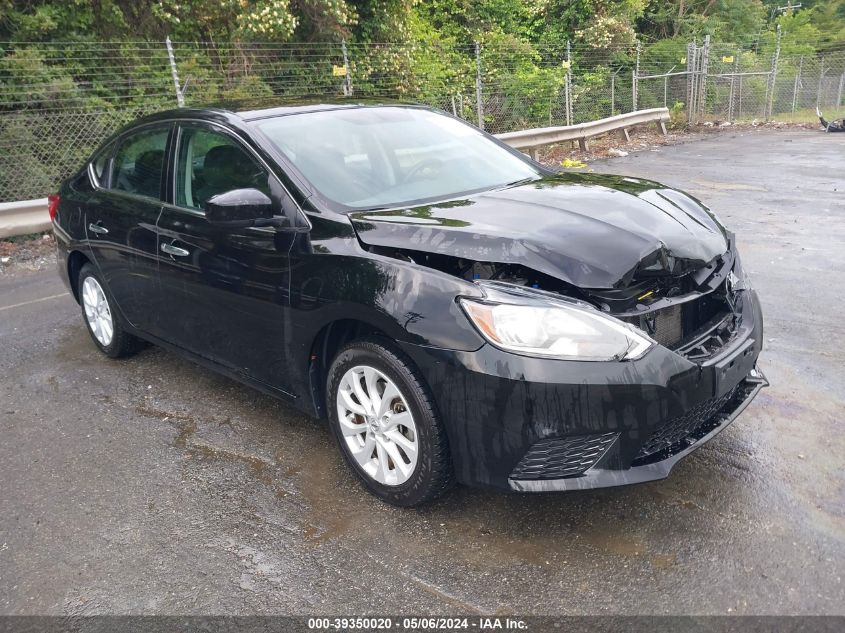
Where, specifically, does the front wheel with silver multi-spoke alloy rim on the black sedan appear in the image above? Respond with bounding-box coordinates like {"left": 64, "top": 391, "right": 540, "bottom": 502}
{"left": 326, "top": 340, "right": 454, "bottom": 506}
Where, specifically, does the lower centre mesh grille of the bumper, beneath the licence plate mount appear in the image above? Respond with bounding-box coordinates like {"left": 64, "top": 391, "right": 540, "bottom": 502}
{"left": 632, "top": 387, "right": 740, "bottom": 466}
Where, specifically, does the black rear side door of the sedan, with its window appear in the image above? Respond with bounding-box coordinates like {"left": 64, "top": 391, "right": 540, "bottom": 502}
{"left": 84, "top": 124, "right": 172, "bottom": 334}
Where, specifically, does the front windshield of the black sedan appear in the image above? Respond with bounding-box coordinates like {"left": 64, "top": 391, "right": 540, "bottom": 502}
{"left": 256, "top": 107, "right": 540, "bottom": 209}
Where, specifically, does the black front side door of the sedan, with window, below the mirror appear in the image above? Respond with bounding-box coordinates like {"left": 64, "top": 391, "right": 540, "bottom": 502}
{"left": 153, "top": 123, "right": 293, "bottom": 391}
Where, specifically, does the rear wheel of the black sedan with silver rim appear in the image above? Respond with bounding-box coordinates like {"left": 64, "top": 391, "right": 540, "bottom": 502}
{"left": 76, "top": 264, "right": 143, "bottom": 358}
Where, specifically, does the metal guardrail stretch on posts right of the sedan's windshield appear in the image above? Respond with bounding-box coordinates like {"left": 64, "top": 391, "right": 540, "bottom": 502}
{"left": 496, "top": 108, "right": 669, "bottom": 160}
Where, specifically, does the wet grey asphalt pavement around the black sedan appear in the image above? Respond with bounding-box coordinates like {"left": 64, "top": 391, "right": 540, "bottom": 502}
{"left": 0, "top": 131, "right": 845, "bottom": 615}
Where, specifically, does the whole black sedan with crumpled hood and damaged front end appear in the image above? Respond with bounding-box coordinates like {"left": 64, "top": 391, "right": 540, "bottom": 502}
{"left": 50, "top": 103, "right": 766, "bottom": 506}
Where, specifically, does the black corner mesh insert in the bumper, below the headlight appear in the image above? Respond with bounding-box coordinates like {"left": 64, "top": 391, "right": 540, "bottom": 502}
{"left": 511, "top": 433, "right": 617, "bottom": 479}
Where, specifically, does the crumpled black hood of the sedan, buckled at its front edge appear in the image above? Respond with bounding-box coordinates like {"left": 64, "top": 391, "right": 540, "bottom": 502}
{"left": 351, "top": 174, "right": 728, "bottom": 289}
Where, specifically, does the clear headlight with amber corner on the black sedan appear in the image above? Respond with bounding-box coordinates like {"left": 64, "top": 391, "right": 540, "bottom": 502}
{"left": 460, "top": 288, "right": 655, "bottom": 361}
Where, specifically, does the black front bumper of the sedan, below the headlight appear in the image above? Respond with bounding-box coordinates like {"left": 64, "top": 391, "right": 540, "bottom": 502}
{"left": 404, "top": 291, "right": 768, "bottom": 492}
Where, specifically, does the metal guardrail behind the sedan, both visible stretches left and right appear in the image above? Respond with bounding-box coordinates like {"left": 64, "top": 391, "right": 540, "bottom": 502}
{"left": 0, "top": 108, "right": 669, "bottom": 238}
